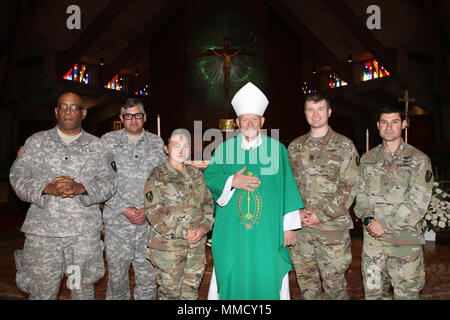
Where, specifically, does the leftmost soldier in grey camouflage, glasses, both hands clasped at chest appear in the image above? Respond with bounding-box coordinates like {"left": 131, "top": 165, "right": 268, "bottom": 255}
{"left": 10, "top": 93, "right": 116, "bottom": 299}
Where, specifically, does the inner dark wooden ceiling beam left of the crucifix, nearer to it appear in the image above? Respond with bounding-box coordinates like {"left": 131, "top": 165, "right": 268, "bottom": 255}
{"left": 100, "top": 0, "right": 184, "bottom": 86}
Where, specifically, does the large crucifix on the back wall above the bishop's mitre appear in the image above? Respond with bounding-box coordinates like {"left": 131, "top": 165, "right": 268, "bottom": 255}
{"left": 192, "top": 37, "right": 264, "bottom": 118}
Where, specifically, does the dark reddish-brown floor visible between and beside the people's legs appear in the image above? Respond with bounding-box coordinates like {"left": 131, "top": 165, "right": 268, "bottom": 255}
{"left": 0, "top": 212, "right": 450, "bottom": 300}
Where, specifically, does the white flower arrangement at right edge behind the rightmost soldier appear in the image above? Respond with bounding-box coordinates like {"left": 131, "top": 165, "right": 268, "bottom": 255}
{"left": 424, "top": 182, "right": 450, "bottom": 232}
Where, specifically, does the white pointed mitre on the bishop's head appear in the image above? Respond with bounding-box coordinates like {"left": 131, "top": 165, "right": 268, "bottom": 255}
{"left": 231, "top": 82, "right": 269, "bottom": 117}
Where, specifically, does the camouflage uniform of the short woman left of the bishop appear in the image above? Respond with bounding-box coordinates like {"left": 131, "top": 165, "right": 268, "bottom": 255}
{"left": 145, "top": 161, "right": 214, "bottom": 300}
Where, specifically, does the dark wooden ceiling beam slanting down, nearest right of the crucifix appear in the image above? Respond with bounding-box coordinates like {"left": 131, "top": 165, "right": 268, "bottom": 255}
{"left": 266, "top": 0, "right": 353, "bottom": 84}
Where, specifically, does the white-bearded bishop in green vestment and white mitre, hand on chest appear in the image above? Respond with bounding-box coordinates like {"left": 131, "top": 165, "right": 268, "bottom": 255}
{"left": 205, "top": 83, "right": 303, "bottom": 300}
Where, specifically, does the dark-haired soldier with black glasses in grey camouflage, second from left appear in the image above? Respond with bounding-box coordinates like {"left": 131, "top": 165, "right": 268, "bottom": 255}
{"left": 102, "top": 98, "right": 167, "bottom": 300}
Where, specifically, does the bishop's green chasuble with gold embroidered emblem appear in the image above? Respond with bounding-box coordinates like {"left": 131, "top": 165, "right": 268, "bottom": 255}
{"left": 205, "top": 134, "right": 303, "bottom": 300}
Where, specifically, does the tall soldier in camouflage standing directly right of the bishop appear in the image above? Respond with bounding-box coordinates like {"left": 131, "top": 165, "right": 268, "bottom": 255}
{"left": 288, "top": 93, "right": 359, "bottom": 299}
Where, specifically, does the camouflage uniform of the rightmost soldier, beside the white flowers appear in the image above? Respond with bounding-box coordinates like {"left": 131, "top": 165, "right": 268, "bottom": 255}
{"left": 355, "top": 140, "right": 433, "bottom": 299}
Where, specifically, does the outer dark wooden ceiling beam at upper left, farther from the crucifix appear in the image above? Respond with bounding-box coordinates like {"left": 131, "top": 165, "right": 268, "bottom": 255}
{"left": 56, "top": 0, "right": 130, "bottom": 76}
